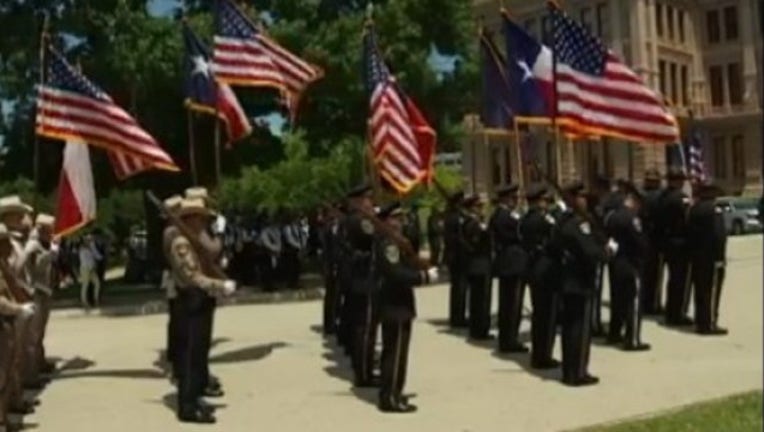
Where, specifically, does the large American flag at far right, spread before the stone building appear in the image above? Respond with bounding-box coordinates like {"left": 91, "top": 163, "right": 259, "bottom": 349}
{"left": 551, "top": 7, "right": 679, "bottom": 143}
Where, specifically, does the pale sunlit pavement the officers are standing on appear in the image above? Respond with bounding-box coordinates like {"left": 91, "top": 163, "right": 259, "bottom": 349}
{"left": 25, "top": 236, "right": 762, "bottom": 432}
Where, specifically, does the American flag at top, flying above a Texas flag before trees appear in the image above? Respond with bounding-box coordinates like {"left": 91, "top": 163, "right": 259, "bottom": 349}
{"left": 213, "top": 0, "right": 323, "bottom": 116}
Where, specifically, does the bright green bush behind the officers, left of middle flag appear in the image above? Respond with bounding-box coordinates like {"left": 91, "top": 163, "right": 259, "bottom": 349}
{"left": 219, "top": 131, "right": 356, "bottom": 213}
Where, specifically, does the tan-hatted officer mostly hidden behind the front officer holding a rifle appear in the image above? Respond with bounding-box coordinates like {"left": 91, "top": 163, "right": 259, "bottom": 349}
{"left": 185, "top": 187, "right": 222, "bottom": 397}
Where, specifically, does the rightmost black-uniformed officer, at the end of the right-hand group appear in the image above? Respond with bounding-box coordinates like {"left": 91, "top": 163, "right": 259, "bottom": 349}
{"left": 687, "top": 182, "right": 727, "bottom": 336}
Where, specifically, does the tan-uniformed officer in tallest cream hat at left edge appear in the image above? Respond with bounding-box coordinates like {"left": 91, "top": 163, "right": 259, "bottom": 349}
{"left": 0, "top": 195, "right": 34, "bottom": 414}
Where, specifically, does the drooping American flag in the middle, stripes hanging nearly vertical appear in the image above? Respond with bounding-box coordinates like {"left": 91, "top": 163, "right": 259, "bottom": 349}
{"left": 364, "top": 25, "right": 436, "bottom": 193}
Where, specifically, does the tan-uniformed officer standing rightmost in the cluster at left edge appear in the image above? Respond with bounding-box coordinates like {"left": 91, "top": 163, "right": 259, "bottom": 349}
{"left": 24, "top": 214, "right": 58, "bottom": 389}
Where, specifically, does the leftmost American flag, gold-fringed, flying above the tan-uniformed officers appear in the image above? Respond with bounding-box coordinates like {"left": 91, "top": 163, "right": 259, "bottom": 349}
{"left": 36, "top": 47, "right": 178, "bottom": 175}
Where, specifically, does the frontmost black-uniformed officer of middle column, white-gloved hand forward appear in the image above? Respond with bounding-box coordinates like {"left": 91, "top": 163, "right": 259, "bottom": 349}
{"left": 377, "top": 202, "right": 438, "bottom": 413}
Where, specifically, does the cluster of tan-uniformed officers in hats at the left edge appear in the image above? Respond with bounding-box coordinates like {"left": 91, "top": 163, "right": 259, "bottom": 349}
{"left": 0, "top": 195, "right": 58, "bottom": 432}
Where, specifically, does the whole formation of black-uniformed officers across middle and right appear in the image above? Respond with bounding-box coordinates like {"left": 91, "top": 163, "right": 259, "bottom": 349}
{"left": 322, "top": 169, "right": 727, "bottom": 412}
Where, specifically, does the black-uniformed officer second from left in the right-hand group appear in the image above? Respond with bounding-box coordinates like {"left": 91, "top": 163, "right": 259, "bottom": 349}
{"left": 462, "top": 195, "right": 491, "bottom": 340}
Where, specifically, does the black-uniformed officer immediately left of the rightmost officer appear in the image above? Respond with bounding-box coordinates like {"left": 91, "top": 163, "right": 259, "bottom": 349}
{"left": 656, "top": 168, "right": 692, "bottom": 326}
